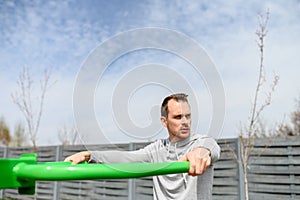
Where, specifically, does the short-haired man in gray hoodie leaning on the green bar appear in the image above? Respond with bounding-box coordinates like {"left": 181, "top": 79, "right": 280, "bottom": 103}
{"left": 65, "top": 94, "right": 220, "bottom": 200}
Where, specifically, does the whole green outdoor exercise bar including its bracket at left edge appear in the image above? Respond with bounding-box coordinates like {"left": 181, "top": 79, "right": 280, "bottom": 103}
{"left": 0, "top": 154, "right": 189, "bottom": 194}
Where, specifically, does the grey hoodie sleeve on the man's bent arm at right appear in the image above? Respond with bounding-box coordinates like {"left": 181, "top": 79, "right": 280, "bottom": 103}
{"left": 196, "top": 136, "right": 221, "bottom": 163}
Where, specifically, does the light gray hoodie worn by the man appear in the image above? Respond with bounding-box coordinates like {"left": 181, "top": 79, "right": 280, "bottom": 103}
{"left": 90, "top": 135, "right": 220, "bottom": 200}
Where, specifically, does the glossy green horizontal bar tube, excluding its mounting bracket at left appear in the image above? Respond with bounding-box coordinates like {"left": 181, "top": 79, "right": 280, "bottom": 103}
{"left": 13, "top": 162, "right": 189, "bottom": 181}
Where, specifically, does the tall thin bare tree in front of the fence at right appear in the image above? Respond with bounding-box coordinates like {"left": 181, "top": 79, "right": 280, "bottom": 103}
{"left": 229, "top": 11, "right": 279, "bottom": 200}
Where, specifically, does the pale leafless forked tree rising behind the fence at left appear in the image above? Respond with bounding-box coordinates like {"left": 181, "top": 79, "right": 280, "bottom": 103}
{"left": 11, "top": 67, "right": 51, "bottom": 151}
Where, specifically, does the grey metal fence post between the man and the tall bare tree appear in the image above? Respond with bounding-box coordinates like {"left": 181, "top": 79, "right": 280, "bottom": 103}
{"left": 235, "top": 138, "right": 246, "bottom": 200}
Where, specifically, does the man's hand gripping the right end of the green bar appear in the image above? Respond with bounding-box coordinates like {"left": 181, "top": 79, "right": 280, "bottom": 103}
{"left": 178, "top": 147, "right": 211, "bottom": 176}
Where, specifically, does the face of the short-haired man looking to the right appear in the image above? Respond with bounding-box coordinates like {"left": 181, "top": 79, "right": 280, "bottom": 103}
{"left": 161, "top": 99, "right": 191, "bottom": 142}
